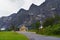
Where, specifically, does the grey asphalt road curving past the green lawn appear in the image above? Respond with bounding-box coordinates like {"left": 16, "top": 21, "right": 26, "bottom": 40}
{"left": 18, "top": 32, "right": 60, "bottom": 40}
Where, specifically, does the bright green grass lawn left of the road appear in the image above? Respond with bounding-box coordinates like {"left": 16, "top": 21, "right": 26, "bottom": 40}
{"left": 0, "top": 32, "right": 28, "bottom": 40}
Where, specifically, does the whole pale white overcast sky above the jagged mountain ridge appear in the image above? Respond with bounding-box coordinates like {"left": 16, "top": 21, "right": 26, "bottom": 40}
{"left": 0, "top": 0, "right": 45, "bottom": 17}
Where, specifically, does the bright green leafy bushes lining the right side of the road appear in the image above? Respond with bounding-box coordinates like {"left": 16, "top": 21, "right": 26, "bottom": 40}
{"left": 39, "top": 24, "right": 60, "bottom": 35}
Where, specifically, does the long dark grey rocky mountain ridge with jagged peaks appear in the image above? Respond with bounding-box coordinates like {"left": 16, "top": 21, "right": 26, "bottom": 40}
{"left": 0, "top": 0, "right": 60, "bottom": 28}
